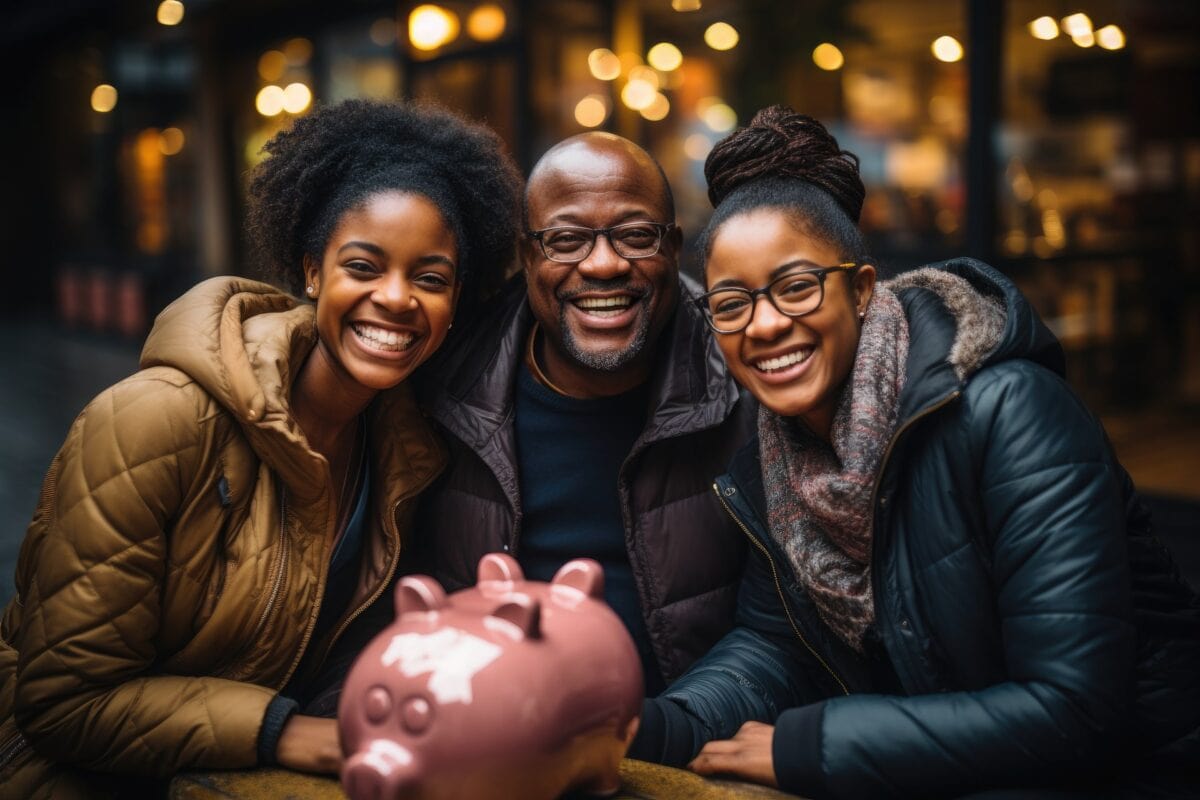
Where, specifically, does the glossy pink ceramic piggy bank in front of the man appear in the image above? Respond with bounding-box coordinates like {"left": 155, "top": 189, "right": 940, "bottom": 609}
{"left": 337, "top": 553, "right": 642, "bottom": 800}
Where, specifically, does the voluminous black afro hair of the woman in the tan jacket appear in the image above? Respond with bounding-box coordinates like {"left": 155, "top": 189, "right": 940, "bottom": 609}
{"left": 247, "top": 100, "right": 521, "bottom": 311}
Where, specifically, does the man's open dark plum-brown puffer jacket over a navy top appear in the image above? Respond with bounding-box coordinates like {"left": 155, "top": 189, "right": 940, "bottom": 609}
{"left": 406, "top": 277, "right": 754, "bottom": 681}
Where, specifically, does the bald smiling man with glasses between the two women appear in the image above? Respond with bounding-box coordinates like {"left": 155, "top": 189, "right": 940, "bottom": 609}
{"left": 409, "top": 133, "right": 754, "bottom": 696}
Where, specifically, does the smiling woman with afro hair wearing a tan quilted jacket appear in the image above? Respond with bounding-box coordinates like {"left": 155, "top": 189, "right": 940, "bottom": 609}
{"left": 0, "top": 101, "right": 521, "bottom": 798}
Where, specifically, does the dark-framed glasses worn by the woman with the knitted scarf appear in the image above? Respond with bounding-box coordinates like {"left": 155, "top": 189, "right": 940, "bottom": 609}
{"left": 695, "top": 261, "right": 866, "bottom": 333}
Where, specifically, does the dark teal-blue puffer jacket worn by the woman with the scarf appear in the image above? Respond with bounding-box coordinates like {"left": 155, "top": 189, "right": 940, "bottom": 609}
{"left": 634, "top": 259, "right": 1200, "bottom": 798}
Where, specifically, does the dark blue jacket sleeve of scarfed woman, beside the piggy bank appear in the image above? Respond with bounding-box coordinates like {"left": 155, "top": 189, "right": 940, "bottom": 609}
{"left": 629, "top": 537, "right": 829, "bottom": 766}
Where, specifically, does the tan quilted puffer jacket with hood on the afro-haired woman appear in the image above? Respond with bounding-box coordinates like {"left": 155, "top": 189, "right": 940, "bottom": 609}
{"left": 0, "top": 278, "right": 445, "bottom": 796}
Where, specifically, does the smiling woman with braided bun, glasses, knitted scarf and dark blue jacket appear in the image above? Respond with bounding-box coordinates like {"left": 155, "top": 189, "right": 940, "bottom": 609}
{"left": 632, "top": 107, "right": 1200, "bottom": 798}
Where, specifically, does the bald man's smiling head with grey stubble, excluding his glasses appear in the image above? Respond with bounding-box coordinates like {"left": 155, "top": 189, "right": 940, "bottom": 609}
{"left": 522, "top": 137, "right": 680, "bottom": 396}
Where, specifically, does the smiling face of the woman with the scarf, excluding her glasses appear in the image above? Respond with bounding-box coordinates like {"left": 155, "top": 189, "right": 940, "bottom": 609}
{"left": 706, "top": 209, "right": 875, "bottom": 439}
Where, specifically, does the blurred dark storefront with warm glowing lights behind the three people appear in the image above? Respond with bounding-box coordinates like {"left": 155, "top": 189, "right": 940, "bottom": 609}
{"left": 0, "top": 0, "right": 1200, "bottom": 434}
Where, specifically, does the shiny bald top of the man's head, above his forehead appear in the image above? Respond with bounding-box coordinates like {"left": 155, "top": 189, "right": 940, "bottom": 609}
{"left": 522, "top": 131, "right": 674, "bottom": 228}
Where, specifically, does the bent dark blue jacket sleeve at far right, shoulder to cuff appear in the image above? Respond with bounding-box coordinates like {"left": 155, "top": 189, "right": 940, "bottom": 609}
{"left": 774, "top": 362, "right": 1134, "bottom": 798}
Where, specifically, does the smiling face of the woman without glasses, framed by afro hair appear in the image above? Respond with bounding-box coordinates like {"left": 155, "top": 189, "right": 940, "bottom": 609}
{"left": 305, "top": 192, "right": 461, "bottom": 392}
